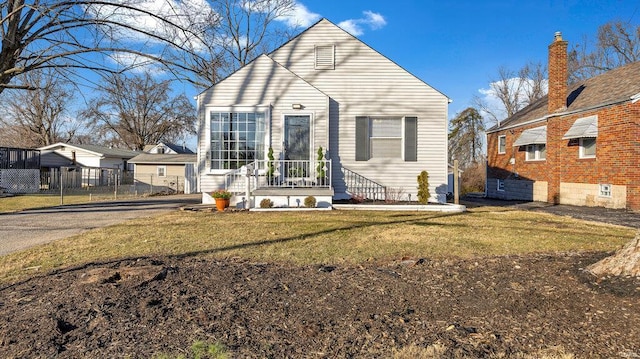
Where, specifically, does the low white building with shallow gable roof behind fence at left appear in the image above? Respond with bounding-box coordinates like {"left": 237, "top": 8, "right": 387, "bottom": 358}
{"left": 38, "top": 142, "right": 139, "bottom": 171}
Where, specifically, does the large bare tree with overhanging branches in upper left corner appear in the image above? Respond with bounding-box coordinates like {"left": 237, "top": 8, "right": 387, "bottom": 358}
{"left": 0, "top": 0, "right": 206, "bottom": 93}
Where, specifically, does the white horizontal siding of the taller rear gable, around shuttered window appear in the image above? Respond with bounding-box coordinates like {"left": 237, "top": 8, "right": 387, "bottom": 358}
{"left": 270, "top": 21, "right": 448, "bottom": 200}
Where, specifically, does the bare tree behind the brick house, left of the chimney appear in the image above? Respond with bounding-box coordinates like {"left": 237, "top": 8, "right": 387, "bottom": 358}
{"left": 474, "top": 63, "right": 548, "bottom": 124}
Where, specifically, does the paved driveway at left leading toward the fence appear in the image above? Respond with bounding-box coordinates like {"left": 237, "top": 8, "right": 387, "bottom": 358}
{"left": 0, "top": 194, "right": 202, "bottom": 255}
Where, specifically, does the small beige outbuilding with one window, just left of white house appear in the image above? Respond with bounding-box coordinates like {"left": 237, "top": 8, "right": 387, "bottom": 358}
{"left": 129, "top": 152, "right": 197, "bottom": 194}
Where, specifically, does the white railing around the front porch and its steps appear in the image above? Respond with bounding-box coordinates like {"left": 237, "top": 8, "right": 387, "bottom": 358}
{"left": 225, "top": 159, "right": 331, "bottom": 193}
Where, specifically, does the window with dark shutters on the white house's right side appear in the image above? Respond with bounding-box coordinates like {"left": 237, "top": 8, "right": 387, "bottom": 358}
{"left": 355, "top": 116, "right": 418, "bottom": 161}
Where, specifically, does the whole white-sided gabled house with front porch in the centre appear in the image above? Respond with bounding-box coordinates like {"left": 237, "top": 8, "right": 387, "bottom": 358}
{"left": 197, "top": 19, "right": 450, "bottom": 205}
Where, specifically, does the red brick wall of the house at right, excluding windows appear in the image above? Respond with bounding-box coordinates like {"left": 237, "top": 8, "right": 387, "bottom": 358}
{"left": 487, "top": 102, "right": 640, "bottom": 210}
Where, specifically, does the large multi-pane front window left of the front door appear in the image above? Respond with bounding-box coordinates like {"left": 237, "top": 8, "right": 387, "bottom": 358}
{"left": 210, "top": 111, "right": 266, "bottom": 170}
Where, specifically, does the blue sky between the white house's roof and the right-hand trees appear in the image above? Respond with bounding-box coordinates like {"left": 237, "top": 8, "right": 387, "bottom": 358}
{"left": 288, "top": 0, "right": 640, "bottom": 117}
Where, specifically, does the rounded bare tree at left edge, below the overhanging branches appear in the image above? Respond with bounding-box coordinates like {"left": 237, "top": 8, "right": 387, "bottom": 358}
{"left": 0, "top": 69, "right": 87, "bottom": 148}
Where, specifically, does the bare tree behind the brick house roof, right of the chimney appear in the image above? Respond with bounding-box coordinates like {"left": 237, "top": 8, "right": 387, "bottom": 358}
{"left": 569, "top": 21, "right": 640, "bottom": 82}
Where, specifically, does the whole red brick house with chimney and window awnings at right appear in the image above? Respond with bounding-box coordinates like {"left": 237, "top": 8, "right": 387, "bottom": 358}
{"left": 486, "top": 33, "right": 640, "bottom": 210}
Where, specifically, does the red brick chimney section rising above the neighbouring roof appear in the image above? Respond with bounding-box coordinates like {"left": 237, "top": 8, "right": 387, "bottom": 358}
{"left": 548, "top": 31, "right": 569, "bottom": 113}
